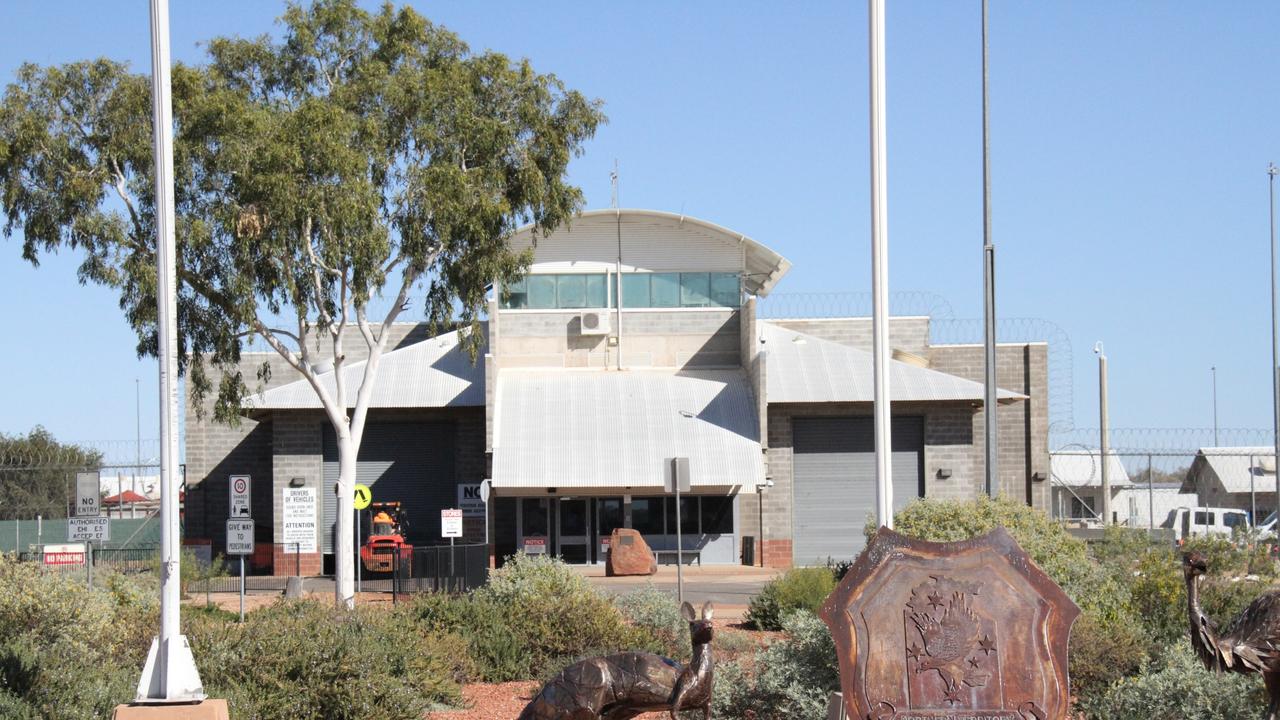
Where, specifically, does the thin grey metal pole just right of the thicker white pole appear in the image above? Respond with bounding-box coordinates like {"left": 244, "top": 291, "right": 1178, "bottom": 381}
{"left": 982, "top": 0, "right": 1000, "bottom": 497}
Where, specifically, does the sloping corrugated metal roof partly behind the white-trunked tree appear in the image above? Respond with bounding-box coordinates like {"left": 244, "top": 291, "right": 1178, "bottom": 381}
{"left": 244, "top": 326, "right": 484, "bottom": 411}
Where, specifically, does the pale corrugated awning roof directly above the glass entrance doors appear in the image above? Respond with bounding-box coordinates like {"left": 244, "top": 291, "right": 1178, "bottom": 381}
{"left": 493, "top": 369, "right": 763, "bottom": 488}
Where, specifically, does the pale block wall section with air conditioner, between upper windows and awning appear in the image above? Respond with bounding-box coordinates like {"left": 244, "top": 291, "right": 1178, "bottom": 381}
{"left": 495, "top": 309, "right": 741, "bottom": 368}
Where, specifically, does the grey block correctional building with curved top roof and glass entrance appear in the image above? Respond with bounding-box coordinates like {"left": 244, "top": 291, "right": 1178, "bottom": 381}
{"left": 186, "top": 209, "right": 1051, "bottom": 574}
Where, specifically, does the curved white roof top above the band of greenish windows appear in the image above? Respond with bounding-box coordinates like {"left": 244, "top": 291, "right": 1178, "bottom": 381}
{"left": 511, "top": 209, "right": 791, "bottom": 297}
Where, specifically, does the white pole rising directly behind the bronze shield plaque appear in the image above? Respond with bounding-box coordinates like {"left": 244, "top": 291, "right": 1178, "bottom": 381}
{"left": 867, "top": 0, "right": 893, "bottom": 528}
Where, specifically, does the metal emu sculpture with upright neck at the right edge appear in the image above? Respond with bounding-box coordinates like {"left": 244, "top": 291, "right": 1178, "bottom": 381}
{"left": 1183, "top": 551, "right": 1280, "bottom": 720}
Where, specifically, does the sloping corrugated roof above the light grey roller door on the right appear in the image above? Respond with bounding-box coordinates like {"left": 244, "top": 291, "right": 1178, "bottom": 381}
{"left": 759, "top": 323, "right": 1027, "bottom": 404}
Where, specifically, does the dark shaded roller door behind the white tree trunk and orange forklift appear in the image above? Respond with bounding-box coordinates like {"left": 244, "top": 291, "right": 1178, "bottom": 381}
{"left": 320, "top": 423, "right": 458, "bottom": 552}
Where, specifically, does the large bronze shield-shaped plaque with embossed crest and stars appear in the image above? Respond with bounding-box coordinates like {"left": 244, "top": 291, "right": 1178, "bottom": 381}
{"left": 822, "top": 520, "right": 1080, "bottom": 720}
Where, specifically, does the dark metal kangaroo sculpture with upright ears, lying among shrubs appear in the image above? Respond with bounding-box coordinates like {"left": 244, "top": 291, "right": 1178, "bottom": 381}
{"left": 520, "top": 602, "right": 716, "bottom": 720}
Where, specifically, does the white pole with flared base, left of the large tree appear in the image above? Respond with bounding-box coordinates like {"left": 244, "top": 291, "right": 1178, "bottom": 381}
{"left": 136, "top": 0, "right": 205, "bottom": 703}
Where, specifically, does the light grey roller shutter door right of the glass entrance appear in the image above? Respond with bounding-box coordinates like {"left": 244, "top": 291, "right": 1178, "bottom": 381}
{"left": 792, "top": 418, "right": 924, "bottom": 565}
